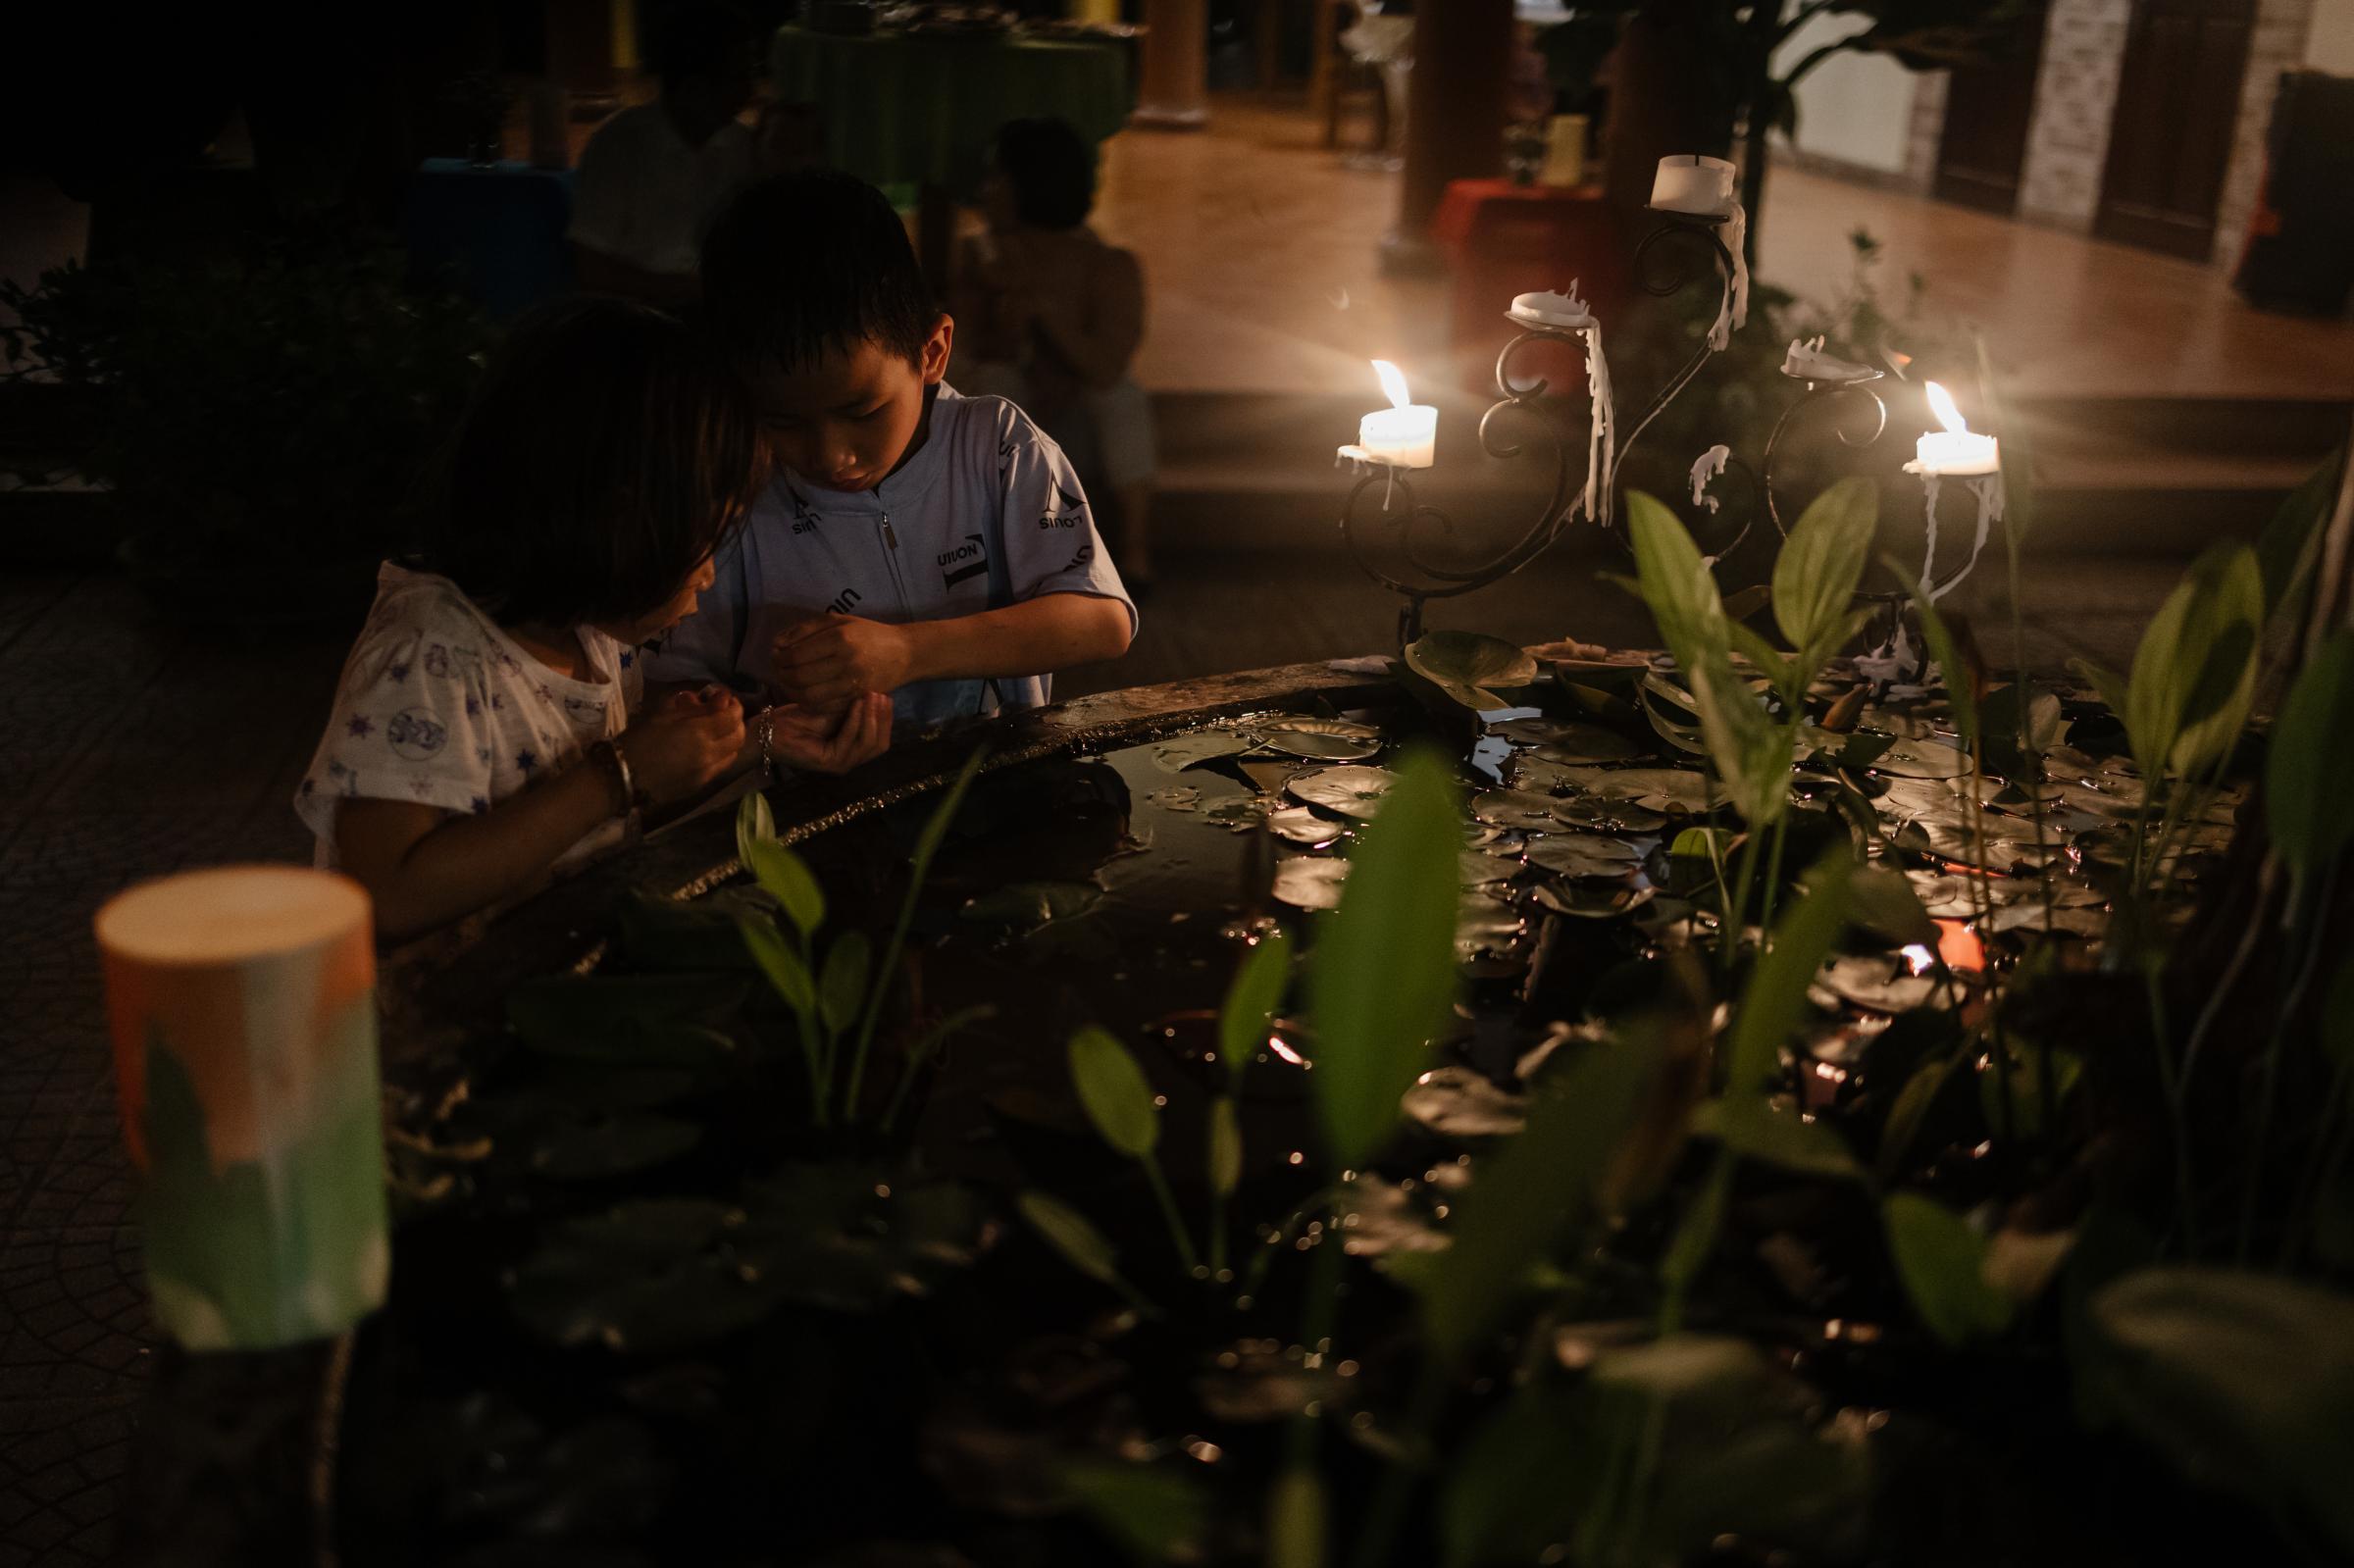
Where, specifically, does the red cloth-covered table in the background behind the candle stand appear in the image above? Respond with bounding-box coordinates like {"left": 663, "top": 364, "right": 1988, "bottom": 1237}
{"left": 1431, "top": 178, "right": 1634, "bottom": 398}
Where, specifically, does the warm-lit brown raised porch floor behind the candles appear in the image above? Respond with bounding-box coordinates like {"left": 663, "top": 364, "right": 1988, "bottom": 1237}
{"left": 1095, "top": 99, "right": 2354, "bottom": 398}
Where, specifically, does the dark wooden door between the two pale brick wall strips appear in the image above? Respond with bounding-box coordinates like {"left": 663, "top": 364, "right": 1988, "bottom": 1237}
{"left": 2093, "top": 0, "right": 2255, "bottom": 262}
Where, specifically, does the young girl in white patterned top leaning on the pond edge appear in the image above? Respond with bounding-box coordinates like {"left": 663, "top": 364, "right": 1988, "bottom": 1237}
{"left": 294, "top": 299, "right": 890, "bottom": 941}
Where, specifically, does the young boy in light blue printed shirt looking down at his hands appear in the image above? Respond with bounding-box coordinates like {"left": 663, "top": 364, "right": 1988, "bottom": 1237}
{"left": 647, "top": 172, "right": 1137, "bottom": 728}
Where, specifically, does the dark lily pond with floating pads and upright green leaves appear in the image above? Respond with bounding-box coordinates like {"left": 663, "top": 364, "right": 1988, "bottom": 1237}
{"left": 330, "top": 471, "right": 2354, "bottom": 1568}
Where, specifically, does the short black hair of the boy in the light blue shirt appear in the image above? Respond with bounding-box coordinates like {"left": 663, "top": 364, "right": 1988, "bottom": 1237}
{"left": 701, "top": 170, "right": 940, "bottom": 372}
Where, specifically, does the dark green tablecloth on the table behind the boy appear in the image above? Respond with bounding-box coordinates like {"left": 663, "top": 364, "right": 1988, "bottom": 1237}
{"left": 770, "top": 25, "right": 1135, "bottom": 195}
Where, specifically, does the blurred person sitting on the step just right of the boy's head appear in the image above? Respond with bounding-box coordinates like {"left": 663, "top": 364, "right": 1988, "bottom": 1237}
{"left": 951, "top": 118, "right": 1155, "bottom": 591}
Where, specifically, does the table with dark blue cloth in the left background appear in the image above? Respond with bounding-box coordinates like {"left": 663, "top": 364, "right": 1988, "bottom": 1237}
{"left": 400, "top": 158, "right": 572, "bottom": 321}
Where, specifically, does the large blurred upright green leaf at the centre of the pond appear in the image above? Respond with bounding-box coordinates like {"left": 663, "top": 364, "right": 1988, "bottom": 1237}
{"left": 1308, "top": 748, "right": 1461, "bottom": 1168}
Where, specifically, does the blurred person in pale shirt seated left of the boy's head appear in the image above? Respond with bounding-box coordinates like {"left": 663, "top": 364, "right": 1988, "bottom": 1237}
{"left": 570, "top": 0, "right": 763, "bottom": 306}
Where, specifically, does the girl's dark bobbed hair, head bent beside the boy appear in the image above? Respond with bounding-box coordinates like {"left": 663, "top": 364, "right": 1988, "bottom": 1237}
{"left": 426, "top": 299, "right": 767, "bottom": 627}
